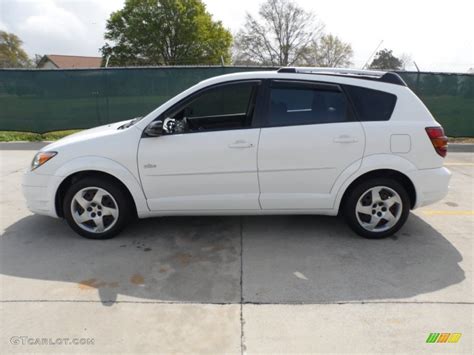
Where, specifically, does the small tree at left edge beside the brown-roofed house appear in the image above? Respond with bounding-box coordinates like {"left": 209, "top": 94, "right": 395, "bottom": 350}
{"left": 0, "top": 31, "right": 31, "bottom": 68}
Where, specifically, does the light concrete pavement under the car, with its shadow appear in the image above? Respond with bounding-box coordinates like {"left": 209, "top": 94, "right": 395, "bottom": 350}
{"left": 0, "top": 150, "right": 474, "bottom": 354}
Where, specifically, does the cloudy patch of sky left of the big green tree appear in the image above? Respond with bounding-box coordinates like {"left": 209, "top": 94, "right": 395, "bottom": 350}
{"left": 0, "top": 0, "right": 123, "bottom": 56}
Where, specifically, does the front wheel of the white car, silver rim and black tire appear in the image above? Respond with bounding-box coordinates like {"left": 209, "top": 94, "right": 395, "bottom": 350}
{"left": 63, "top": 177, "right": 131, "bottom": 239}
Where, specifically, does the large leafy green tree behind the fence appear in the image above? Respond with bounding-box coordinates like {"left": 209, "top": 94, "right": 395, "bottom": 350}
{"left": 101, "top": 0, "right": 232, "bottom": 66}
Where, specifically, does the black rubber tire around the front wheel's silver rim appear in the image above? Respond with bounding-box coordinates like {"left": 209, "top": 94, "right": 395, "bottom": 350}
{"left": 63, "top": 177, "right": 133, "bottom": 240}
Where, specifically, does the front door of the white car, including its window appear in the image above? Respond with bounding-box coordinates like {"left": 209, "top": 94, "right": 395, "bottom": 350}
{"left": 138, "top": 81, "right": 261, "bottom": 212}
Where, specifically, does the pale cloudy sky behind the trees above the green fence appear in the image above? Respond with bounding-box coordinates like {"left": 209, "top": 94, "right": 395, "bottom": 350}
{"left": 0, "top": 0, "right": 474, "bottom": 72}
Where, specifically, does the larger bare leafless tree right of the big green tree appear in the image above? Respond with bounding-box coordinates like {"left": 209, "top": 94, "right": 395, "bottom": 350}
{"left": 234, "top": 0, "right": 324, "bottom": 66}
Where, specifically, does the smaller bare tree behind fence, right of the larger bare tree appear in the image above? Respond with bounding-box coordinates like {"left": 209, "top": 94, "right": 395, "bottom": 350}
{"left": 305, "top": 34, "right": 354, "bottom": 68}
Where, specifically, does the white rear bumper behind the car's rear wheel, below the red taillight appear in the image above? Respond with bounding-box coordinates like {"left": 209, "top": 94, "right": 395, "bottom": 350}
{"left": 410, "top": 167, "right": 451, "bottom": 208}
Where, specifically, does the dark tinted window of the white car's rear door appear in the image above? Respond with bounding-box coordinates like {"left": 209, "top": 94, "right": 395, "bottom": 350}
{"left": 269, "top": 82, "right": 350, "bottom": 126}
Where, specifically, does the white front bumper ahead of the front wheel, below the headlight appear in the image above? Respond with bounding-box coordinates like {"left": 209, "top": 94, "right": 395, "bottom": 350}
{"left": 21, "top": 170, "right": 60, "bottom": 218}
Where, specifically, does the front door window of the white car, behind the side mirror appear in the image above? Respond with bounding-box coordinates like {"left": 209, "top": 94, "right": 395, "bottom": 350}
{"left": 163, "top": 81, "right": 260, "bottom": 134}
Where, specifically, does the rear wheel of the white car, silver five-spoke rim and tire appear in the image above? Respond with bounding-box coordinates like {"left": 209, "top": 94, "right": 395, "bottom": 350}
{"left": 344, "top": 178, "right": 410, "bottom": 238}
